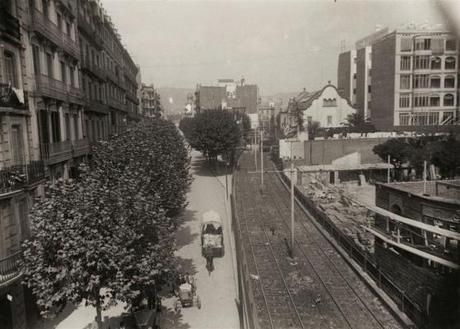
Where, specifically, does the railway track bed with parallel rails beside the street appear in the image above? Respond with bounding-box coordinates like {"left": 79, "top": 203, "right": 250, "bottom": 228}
{"left": 235, "top": 154, "right": 400, "bottom": 329}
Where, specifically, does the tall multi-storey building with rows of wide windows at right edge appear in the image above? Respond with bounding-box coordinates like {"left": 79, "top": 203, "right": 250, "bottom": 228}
{"left": 371, "top": 26, "right": 459, "bottom": 131}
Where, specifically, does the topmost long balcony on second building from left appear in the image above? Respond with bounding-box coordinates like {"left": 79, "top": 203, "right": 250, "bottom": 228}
{"left": 31, "top": 9, "right": 80, "bottom": 58}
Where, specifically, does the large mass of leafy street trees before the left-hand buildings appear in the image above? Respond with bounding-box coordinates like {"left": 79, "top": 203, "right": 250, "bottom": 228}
{"left": 23, "top": 119, "right": 191, "bottom": 328}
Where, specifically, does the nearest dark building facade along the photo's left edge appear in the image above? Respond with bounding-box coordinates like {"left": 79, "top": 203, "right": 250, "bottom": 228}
{"left": 0, "top": 0, "right": 45, "bottom": 329}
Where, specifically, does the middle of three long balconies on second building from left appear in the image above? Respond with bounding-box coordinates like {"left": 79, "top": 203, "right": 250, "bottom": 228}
{"left": 35, "top": 75, "right": 83, "bottom": 104}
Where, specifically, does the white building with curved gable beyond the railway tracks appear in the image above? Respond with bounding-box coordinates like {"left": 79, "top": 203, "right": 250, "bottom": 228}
{"left": 296, "top": 84, "right": 357, "bottom": 129}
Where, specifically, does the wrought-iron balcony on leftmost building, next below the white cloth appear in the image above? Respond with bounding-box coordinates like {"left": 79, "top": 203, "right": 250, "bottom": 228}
{"left": 0, "top": 161, "right": 45, "bottom": 197}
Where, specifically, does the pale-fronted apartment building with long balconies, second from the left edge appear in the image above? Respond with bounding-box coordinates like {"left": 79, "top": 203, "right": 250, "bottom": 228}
{"left": 23, "top": 0, "right": 89, "bottom": 180}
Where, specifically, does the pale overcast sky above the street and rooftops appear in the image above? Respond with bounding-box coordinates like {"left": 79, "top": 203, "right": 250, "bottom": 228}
{"left": 102, "top": 0, "right": 443, "bottom": 95}
